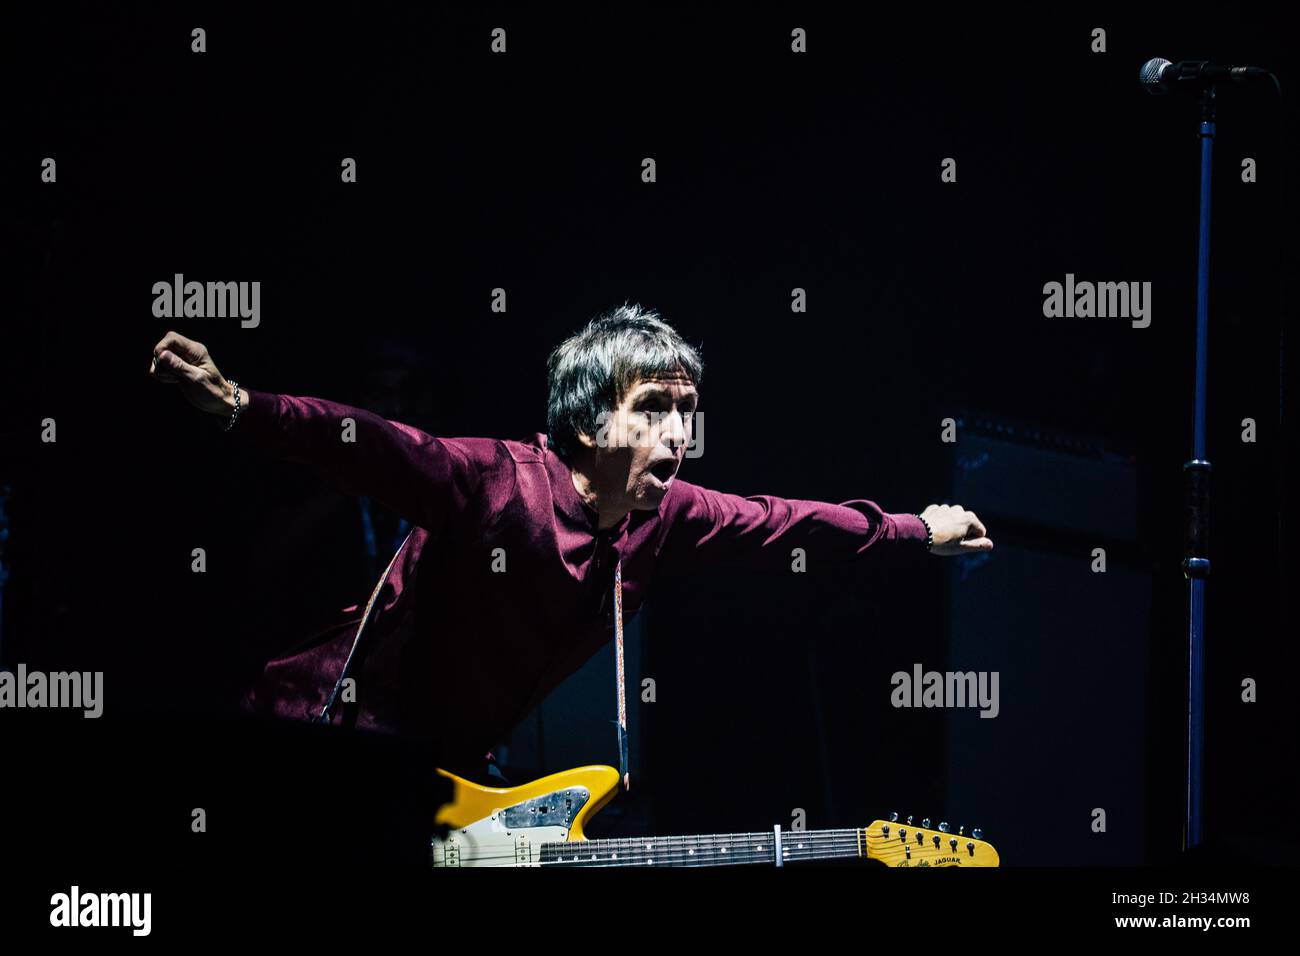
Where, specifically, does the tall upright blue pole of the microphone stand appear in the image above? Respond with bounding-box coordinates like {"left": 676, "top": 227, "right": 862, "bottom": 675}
{"left": 1183, "top": 85, "right": 1214, "bottom": 851}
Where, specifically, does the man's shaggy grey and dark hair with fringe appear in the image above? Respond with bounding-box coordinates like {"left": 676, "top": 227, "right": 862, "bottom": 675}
{"left": 546, "top": 302, "right": 705, "bottom": 462}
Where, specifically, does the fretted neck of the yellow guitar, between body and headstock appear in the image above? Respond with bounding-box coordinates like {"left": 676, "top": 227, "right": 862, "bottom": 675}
{"left": 541, "top": 830, "right": 870, "bottom": 866}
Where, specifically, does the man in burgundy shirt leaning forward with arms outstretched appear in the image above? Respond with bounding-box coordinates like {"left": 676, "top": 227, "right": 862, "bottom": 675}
{"left": 150, "top": 304, "right": 993, "bottom": 785}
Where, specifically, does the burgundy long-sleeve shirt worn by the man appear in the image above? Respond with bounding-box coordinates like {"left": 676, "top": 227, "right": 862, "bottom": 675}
{"left": 229, "top": 389, "right": 926, "bottom": 765}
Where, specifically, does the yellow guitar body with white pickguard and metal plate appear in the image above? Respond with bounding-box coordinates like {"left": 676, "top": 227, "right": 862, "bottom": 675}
{"left": 433, "top": 766, "right": 619, "bottom": 866}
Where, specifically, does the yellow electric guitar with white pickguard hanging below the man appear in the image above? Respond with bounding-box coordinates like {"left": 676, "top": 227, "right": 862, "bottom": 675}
{"left": 433, "top": 766, "right": 998, "bottom": 868}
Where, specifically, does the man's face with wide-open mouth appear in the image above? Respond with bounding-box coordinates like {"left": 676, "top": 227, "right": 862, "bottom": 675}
{"left": 593, "top": 373, "right": 699, "bottom": 511}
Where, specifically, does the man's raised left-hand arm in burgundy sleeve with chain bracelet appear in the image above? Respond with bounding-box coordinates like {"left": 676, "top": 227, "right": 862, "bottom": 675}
{"left": 150, "top": 332, "right": 480, "bottom": 531}
